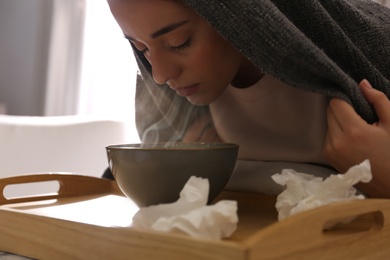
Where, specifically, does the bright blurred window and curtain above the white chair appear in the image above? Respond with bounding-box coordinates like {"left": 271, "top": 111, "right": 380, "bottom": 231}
{"left": 0, "top": 0, "right": 137, "bottom": 120}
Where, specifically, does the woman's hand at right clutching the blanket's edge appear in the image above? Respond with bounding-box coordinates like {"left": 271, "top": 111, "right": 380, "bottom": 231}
{"left": 324, "top": 80, "right": 390, "bottom": 197}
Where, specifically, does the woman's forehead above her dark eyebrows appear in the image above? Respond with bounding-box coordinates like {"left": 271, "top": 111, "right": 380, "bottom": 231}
{"left": 107, "top": 0, "right": 198, "bottom": 39}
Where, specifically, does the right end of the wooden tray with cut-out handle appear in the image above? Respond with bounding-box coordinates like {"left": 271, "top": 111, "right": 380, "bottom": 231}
{"left": 247, "top": 199, "right": 390, "bottom": 255}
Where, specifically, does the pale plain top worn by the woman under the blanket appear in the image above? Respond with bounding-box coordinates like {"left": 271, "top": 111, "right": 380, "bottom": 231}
{"left": 210, "top": 75, "right": 333, "bottom": 193}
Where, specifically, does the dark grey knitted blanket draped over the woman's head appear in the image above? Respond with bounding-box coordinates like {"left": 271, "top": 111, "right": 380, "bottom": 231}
{"left": 135, "top": 0, "right": 390, "bottom": 141}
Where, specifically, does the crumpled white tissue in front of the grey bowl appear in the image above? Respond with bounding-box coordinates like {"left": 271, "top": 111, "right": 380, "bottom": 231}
{"left": 132, "top": 176, "right": 238, "bottom": 240}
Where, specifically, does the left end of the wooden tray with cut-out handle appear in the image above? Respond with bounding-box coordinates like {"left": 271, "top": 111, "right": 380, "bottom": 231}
{"left": 0, "top": 172, "right": 122, "bottom": 205}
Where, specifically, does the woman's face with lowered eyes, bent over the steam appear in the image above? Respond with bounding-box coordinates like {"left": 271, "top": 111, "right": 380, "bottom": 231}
{"left": 108, "top": 0, "right": 247, "bottom": 105}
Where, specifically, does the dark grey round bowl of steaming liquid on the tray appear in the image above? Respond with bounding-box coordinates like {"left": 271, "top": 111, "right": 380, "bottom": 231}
{"left": 106, "top": 143, "right": 238, "bottom": 207}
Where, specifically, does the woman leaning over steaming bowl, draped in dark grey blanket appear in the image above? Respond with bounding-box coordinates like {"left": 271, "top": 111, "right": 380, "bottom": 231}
{"left": 108, "top": 0, "right": 390, "bottom": 197}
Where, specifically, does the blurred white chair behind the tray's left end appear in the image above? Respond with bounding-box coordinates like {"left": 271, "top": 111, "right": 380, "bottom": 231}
{"left": 0, "top": 115, "right": 137, "bottom": 196}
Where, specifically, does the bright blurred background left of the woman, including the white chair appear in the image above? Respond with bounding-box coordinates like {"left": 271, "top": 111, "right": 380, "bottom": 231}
{"left": 0, "top": 0, "right": 139, "bottom": 183}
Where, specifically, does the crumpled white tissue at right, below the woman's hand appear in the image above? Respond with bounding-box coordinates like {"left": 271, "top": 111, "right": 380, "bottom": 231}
{"left": 272, "top": 160, "right": 372, "bottom": 225}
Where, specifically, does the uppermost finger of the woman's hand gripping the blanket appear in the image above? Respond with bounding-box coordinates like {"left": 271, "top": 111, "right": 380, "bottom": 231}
{"left": 359, "top": 79, "right": 390, "bottom": 127}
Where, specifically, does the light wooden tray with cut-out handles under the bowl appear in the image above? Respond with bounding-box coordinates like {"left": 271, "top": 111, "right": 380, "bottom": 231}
{"left": 0, "top": 174, "right": 390, "bottom": 260}
